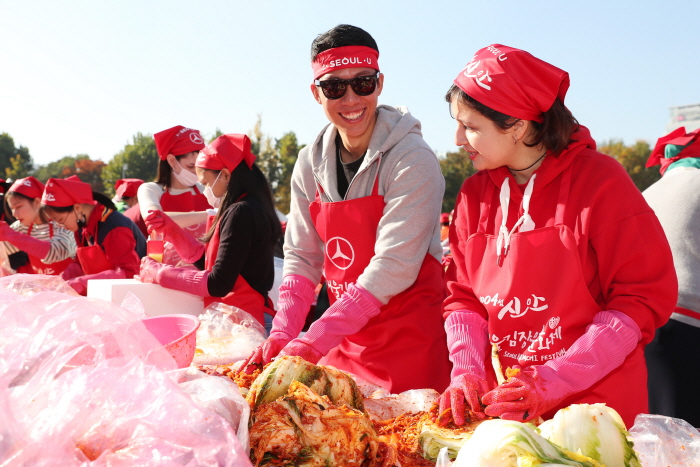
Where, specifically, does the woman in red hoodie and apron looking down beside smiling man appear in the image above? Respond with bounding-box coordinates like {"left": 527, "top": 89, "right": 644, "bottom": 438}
{"left": 440, "top": 44, "right": 678, "bottom": 426}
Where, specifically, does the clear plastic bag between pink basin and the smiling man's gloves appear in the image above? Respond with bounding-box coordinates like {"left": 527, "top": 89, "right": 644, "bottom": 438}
{"left": 194, "top": 302, "right": 267, "bottom": 365}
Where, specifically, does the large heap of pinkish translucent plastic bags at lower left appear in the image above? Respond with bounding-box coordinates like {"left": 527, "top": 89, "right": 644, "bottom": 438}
{"left": 0, "top": 275, "right": 250, "bottom": 467}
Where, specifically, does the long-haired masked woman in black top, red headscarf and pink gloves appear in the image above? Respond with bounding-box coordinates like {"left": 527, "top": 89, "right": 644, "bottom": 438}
{"left": 140, "top": 134, "right": 282, "bottom": 324}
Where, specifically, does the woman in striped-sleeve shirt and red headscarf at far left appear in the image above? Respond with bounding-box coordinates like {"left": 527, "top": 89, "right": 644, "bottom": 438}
{"left": 0, "top": 177, "right": 75, "bottom": 275}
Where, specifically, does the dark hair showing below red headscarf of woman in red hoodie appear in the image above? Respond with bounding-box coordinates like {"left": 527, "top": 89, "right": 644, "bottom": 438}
{"left": 445, "top": 84, "right": 579, "bottom": 157}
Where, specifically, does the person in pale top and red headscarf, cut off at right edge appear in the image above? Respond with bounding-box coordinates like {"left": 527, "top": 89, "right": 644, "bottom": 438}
{"left": 642, "top": 127, "right": 700, "bottom": 427}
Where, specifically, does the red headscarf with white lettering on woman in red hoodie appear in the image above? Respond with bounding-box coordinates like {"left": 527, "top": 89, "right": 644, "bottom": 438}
{"left": 454, "top": 44, "right": 569, "bottom": 123}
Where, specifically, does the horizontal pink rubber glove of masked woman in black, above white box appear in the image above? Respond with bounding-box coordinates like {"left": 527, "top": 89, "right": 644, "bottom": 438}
{"left": 139, "top": 256, "right": 209, "bottom": 297}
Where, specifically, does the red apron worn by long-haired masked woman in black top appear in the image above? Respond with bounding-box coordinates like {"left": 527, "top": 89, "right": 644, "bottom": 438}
{"left": 204, "top": 216, "right": 275, "bottom": 326}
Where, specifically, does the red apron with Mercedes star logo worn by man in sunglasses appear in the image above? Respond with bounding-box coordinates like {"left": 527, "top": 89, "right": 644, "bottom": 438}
{"left": 309, "top": 168, "right": 451, "bottom": 393}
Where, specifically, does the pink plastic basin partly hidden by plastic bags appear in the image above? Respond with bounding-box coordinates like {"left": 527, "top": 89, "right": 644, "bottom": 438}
{"left": 141, "top": 315, "right": 199, "bottom": 368}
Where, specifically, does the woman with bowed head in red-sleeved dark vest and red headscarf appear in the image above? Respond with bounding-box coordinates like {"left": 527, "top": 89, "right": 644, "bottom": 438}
{"left": 41, "top": 175, "right": 146, "bottom": 295}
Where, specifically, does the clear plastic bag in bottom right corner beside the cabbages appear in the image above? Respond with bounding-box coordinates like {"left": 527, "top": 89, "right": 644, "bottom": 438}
{"left": 629, "top": 414, "right": 700, "bottom": 467}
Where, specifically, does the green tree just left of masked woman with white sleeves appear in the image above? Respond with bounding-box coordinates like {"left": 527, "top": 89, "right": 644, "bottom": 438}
{"left": 102, "top": 133, "right": 160, "bottom": 196}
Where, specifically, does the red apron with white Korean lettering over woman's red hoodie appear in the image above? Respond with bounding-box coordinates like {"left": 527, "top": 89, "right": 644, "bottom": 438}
{"left": 464, "top": 167, "right": 648, "bottom": 427}
